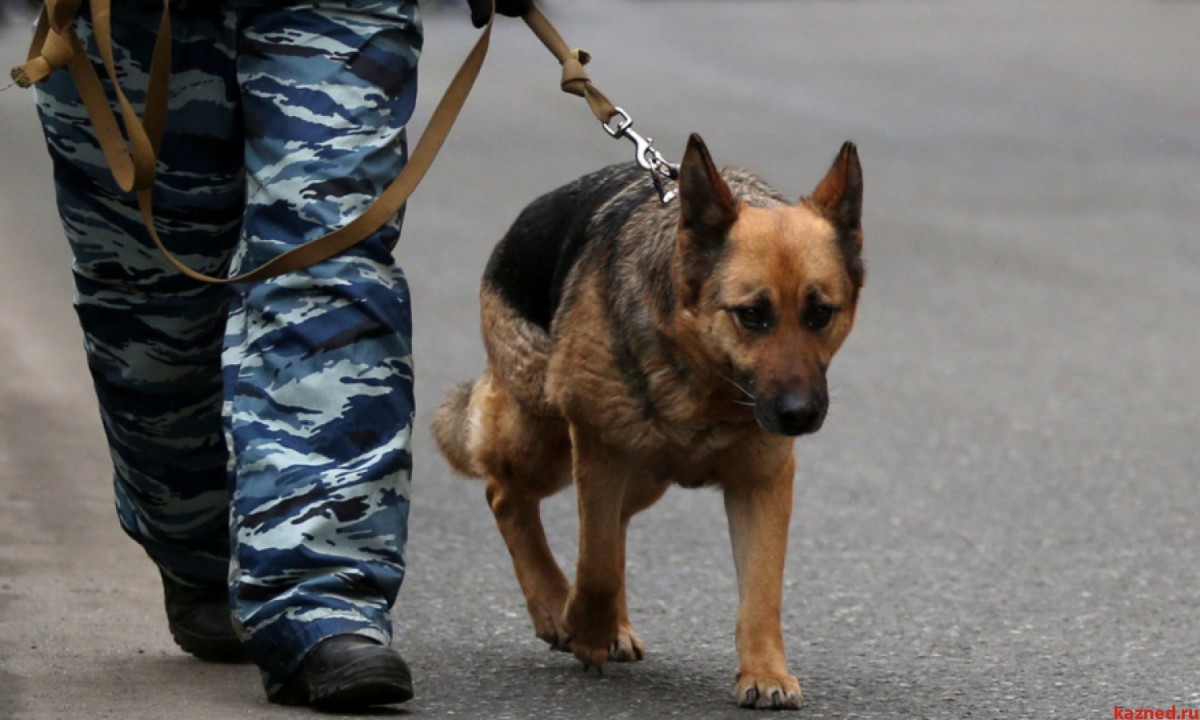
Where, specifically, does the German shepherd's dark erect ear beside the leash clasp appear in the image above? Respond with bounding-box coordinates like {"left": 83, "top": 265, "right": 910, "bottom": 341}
{"left": 676, "top": 133, "right": 738, "bottom": 306}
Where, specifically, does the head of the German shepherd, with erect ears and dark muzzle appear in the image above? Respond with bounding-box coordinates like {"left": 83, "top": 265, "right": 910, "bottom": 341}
{"left": 672, "top": 134, "right": 865, "bottom": 436}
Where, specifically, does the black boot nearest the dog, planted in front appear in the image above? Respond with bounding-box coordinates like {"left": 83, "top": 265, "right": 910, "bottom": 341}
{"left": 270, "top": 635, "right": 413, "bottom": 710}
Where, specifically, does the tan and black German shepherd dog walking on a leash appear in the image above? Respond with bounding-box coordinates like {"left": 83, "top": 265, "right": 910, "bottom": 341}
{"left": 433, "top": 134, "right": 865, "bottom": 708}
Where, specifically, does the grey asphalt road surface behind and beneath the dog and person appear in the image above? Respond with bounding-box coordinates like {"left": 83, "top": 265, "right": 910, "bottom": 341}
{"left": 0, "top": 0, "right": 1200, "bottom": 720}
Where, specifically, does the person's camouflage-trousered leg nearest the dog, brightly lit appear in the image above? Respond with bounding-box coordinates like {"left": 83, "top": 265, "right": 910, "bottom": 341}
{"left": 223, "top": 0, "right": 421, "bottom": 701}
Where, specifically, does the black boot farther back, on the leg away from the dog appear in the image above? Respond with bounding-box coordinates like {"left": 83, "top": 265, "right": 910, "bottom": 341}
{"left": 162, "top": 572, "right": 248, "bottom": 662}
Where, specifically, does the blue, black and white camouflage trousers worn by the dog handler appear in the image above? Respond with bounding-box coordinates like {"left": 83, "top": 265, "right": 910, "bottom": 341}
{"left": 38, "top": 0, "right": 422, "bottom": 694}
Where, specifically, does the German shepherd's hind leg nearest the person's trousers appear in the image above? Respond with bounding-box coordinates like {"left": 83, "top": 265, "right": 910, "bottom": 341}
{"left": 479, "top": 384, "right": 570, "bottom": 650}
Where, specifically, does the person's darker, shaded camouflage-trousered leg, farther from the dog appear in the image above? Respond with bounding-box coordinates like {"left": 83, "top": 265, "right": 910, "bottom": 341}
{"left": 37, "top": 4, "right": 242, "bottom": 590}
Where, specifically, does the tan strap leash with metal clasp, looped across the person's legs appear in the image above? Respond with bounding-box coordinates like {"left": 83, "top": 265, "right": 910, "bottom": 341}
{"left": 12, "top": 0, "right": 678, "bottom": 284}
